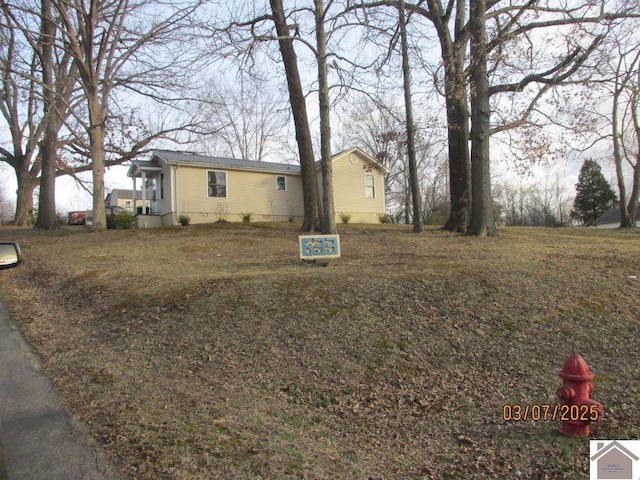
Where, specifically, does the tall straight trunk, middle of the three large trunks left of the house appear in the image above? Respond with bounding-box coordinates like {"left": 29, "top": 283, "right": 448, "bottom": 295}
{"left": 36, "top": 0, "right": 58, "bottom": 230}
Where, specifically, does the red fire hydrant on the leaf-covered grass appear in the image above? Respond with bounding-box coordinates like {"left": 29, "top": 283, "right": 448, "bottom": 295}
{"left": 557, "top": 353, "right": 604, "bottom": 437}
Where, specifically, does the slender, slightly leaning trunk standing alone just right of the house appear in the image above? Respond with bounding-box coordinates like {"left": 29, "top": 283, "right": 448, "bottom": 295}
{"left": 398, "top": 0, "right": 422, "bottom": 233}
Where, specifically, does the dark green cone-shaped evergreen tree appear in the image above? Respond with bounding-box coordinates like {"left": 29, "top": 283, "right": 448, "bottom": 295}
{"left": 571, "top": 160, "right": 617, "bottom": 225}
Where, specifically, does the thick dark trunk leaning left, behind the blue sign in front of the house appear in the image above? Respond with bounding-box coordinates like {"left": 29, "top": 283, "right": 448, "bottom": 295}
{"left": 270, "top": 0, "right": 320, "bottom": 232}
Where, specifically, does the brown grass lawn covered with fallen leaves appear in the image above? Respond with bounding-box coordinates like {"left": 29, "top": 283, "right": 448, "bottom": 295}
{"left": 0, "top": 224, "right": 640, "bottom": 480}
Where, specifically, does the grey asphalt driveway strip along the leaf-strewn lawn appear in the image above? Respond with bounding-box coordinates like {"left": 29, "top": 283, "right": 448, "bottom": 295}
{"left": 0, "top": 304, "right": 124, "bottom": 480}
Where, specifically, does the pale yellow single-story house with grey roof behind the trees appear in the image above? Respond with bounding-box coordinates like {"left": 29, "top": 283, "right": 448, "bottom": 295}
{"left": 122, "top": 148, "right": 388, "bottom": 227}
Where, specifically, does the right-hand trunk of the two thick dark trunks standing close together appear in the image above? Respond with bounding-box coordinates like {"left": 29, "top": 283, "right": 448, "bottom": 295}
{"left": 469, "top": 0, "right": 498, "bottom": 236}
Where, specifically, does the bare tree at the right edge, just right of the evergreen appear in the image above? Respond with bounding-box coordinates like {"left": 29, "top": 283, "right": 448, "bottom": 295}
{"left": 546, "top": 5, "right": 640, "bottom": 228}
